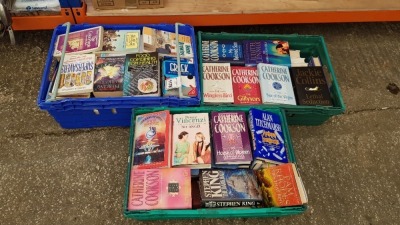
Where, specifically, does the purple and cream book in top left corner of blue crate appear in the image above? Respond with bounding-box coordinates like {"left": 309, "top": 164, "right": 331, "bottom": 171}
{"left": 53, "top": 26, "right": 103, "bottom": 57}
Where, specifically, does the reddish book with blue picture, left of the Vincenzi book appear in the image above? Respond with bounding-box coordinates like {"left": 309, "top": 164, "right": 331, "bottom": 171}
{"left": 132, "top": 110, "right": 171, "bottom": 169}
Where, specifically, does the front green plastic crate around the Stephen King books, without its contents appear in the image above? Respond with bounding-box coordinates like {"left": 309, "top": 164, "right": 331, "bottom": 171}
{"left": 123, "top": 106, "right": 307, "bottom": 220}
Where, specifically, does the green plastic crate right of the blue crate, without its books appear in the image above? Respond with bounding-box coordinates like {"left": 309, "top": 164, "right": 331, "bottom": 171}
{"left": 197, "top": 31, "right": 345, "bottom": 125}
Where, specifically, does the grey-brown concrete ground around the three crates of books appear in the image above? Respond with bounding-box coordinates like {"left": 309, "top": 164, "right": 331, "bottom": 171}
{"left": 0, "top": 23, "right": 400, "bottom": 225}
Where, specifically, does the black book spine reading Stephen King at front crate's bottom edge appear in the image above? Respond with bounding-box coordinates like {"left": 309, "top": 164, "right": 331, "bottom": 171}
{"left": 201, "top": 199, "right": 262, "bottom": 208}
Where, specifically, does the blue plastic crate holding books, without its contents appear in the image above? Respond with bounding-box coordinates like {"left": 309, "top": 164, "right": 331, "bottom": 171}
{"left": 37, "top": 24, "right": 201, "bottom": 128}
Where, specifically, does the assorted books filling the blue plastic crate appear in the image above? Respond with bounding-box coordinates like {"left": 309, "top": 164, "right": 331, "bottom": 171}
{"left": 48, "top": 26, "right": 199, "bottom": 99}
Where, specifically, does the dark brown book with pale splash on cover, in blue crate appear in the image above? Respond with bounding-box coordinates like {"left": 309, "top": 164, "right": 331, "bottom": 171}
{"left": 93, "top": 56, "right": 125, "bottom": 97}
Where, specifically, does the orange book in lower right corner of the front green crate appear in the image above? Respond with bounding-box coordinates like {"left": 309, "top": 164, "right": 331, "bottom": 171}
{"left": 256, "top": 163, "right": 308, "bottom": 207}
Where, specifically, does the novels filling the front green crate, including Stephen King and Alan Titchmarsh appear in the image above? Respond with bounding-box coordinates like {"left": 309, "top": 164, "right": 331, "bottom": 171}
{"left": 128, "top": 108, "right": 307, "bottom": 211}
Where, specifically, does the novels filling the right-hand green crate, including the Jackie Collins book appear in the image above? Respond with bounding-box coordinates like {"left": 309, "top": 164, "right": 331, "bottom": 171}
{"left": 201, "top": 40, "right": 333, "bottom": 106}
